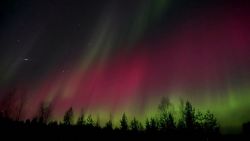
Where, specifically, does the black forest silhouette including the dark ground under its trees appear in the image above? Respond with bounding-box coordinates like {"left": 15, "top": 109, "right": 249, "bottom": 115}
{"left": 0, "top": 89, "right": 250, "bottom": 140}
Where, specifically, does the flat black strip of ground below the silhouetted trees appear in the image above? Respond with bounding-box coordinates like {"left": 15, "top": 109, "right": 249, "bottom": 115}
{"left": 1, "top": 126, "right": 250, "bottom": 141}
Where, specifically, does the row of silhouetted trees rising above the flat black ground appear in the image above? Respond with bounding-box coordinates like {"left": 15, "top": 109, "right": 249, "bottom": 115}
{"left": 0, "top": 92, "right": 220, "bottom": 135}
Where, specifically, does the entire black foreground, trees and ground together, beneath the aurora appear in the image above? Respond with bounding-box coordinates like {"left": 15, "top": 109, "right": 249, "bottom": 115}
{"left": 0, "top": 100, "right": 250, "bottom": 141}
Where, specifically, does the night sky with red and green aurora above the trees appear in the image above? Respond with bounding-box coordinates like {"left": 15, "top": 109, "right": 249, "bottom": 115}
{"left": 0, "top": 0, "right": 250, "bottom": 133}
